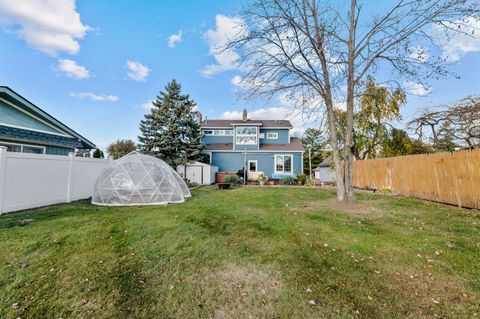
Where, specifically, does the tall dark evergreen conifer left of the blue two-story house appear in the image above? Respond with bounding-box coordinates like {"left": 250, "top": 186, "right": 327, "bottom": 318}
{"left": 138, "top": 80, "right": 204, "bottom": 167}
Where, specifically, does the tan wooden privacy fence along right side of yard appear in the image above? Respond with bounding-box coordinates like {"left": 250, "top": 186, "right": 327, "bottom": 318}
{"left": 353, "top": 150, "right": 480, "bottom": 209}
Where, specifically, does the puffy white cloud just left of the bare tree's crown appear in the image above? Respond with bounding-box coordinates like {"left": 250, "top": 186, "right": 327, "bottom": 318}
{"left": 202, "top": 14, "right": 245, "bottom": 78}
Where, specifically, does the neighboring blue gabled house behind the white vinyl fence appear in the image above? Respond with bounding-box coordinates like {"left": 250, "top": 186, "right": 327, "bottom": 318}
{"left": 0, "top": 86, "right": 95, "bottom": 155}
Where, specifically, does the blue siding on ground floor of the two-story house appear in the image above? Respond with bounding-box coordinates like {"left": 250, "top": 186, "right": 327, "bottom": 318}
{"left": 211, "top": 152, "right": 303, "bottom": 178}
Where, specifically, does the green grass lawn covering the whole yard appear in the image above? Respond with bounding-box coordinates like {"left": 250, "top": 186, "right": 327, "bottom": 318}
{"left": 0, "top": 187, "right": 480, "bottom": 318}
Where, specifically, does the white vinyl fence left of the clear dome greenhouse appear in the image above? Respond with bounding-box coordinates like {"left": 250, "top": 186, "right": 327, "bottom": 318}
{"left": 0, "top": 146, "right": 110, "bottom": 214}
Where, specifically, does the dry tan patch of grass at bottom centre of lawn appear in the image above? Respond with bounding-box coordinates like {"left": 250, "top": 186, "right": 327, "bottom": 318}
{"left": 209, "top": 264, "right": 282, "bottom": 319}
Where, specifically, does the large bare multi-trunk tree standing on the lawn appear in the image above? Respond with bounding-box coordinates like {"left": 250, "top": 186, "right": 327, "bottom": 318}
{"left": 224, "top": 0, "right": 478, "bottom": 201}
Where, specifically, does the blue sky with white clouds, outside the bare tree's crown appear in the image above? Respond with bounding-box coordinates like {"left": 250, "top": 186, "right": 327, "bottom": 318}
{"left": 0, "top": 0, "right": 480, "bottom": 148}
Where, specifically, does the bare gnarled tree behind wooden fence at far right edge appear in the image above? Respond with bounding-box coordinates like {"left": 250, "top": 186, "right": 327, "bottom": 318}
{"left": 408, "top": 96, "right": 480, "bottom": 150}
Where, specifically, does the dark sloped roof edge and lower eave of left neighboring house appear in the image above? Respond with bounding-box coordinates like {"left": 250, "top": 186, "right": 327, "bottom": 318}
{"left": 0, "top": 86, "right": 95, "bottom": 149}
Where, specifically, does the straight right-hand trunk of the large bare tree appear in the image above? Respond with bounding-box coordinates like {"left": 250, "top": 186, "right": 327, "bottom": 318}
{"left": 344, "top": 0, "right": 356, "bottom": 202}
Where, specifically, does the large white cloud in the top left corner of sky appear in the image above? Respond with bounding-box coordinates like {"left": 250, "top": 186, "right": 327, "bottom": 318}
{"left": 0, "top": 0, "right": 90, "bottom": 56}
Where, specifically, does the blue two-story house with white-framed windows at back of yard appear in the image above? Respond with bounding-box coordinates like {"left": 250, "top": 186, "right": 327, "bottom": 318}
{"left": 201, "top": 110, "right": 304, "bottom": 179}
